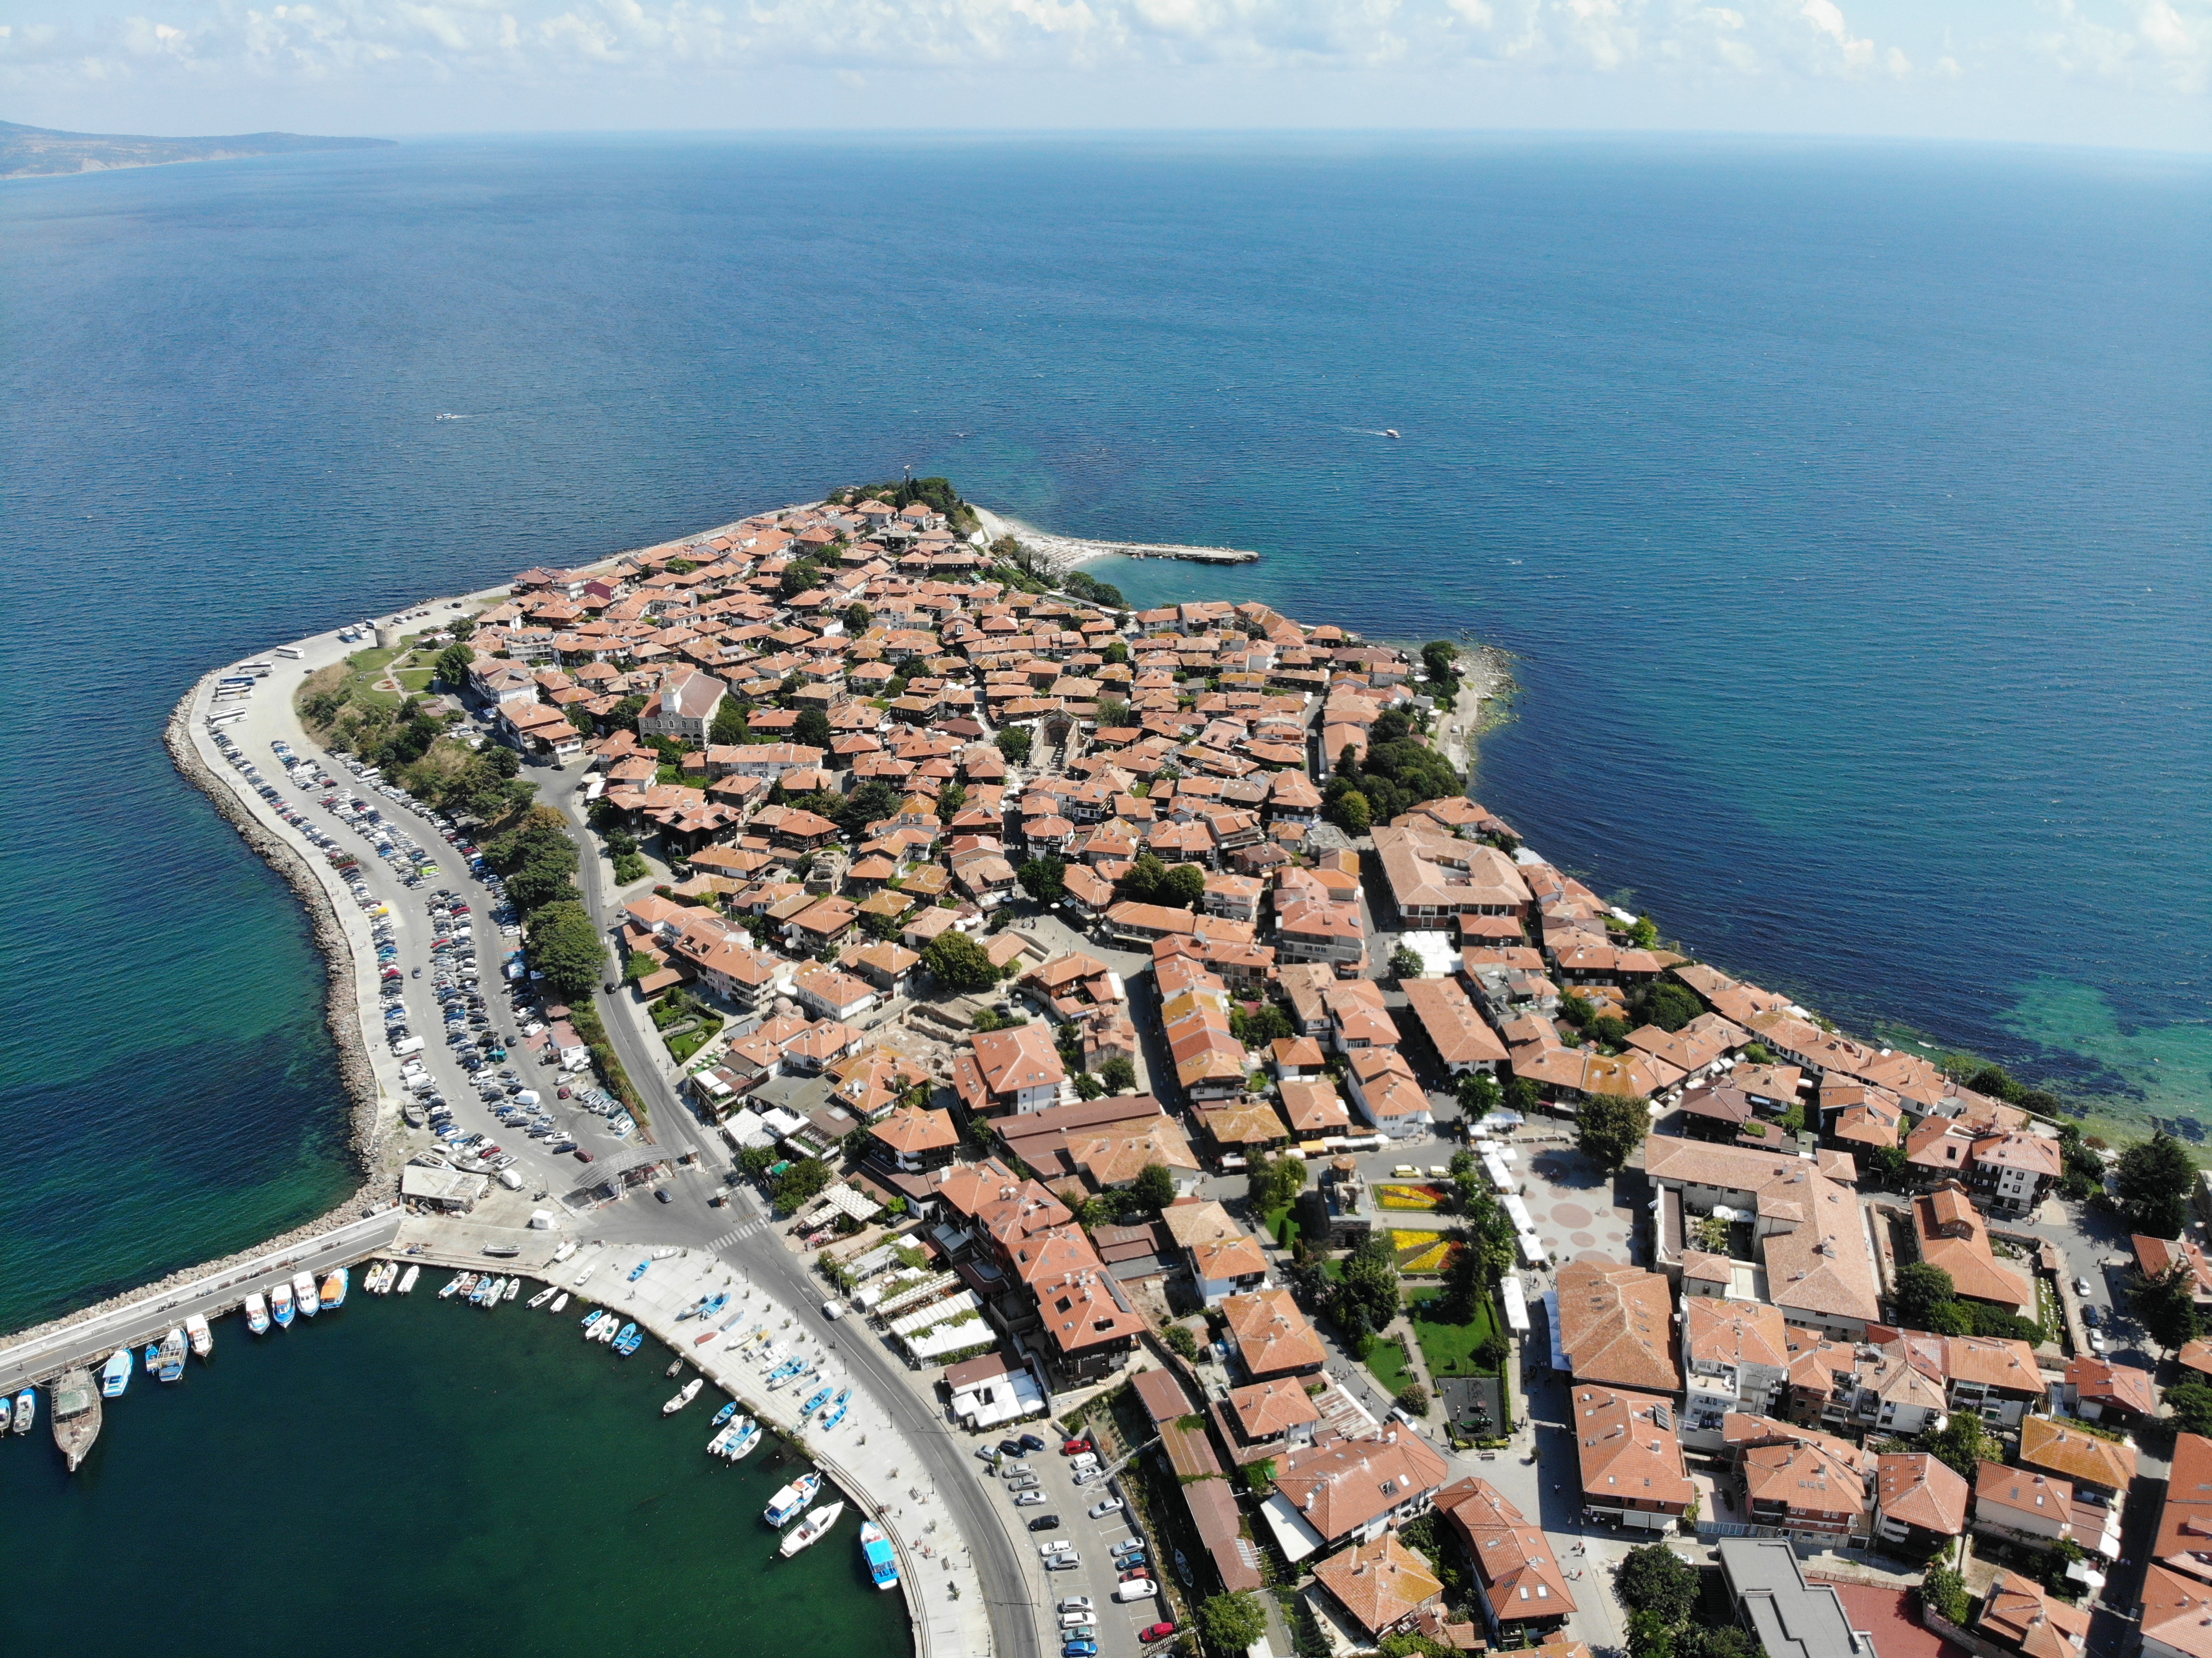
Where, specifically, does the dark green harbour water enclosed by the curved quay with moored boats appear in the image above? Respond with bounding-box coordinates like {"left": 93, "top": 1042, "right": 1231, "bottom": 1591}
{"left": 0, "top": 1273, "right": 909, "bottom": 1658}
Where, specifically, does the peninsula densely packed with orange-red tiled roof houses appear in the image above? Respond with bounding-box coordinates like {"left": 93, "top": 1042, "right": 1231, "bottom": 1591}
{"left": 0, "top": 480, "right": 2177, "bottom": 1658}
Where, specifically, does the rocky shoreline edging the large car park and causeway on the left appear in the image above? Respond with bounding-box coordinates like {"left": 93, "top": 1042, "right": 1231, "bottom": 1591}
{"left": 9, "top": 678, "right": 400, "bottom": 1342}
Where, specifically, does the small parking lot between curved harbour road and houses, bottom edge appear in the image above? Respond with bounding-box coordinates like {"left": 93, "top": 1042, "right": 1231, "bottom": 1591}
{"left": 976, "top": 1423, "right": 1166, "bottom": 1658}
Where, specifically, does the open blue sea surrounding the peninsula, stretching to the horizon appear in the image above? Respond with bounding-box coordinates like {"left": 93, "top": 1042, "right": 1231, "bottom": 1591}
{"left": 0, "top": 139, "right": 2212, "bottom": 1326}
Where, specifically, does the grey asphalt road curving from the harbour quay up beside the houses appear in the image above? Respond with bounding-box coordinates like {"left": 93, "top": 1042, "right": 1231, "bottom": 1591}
{"left": 542, "top": 778, "right": 1044, "bottom": 1658}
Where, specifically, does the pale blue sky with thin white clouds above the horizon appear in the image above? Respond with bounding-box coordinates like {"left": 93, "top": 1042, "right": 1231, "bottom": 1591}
{"left": 0, "top": 0, "right": 2212, "bottom": 151}
